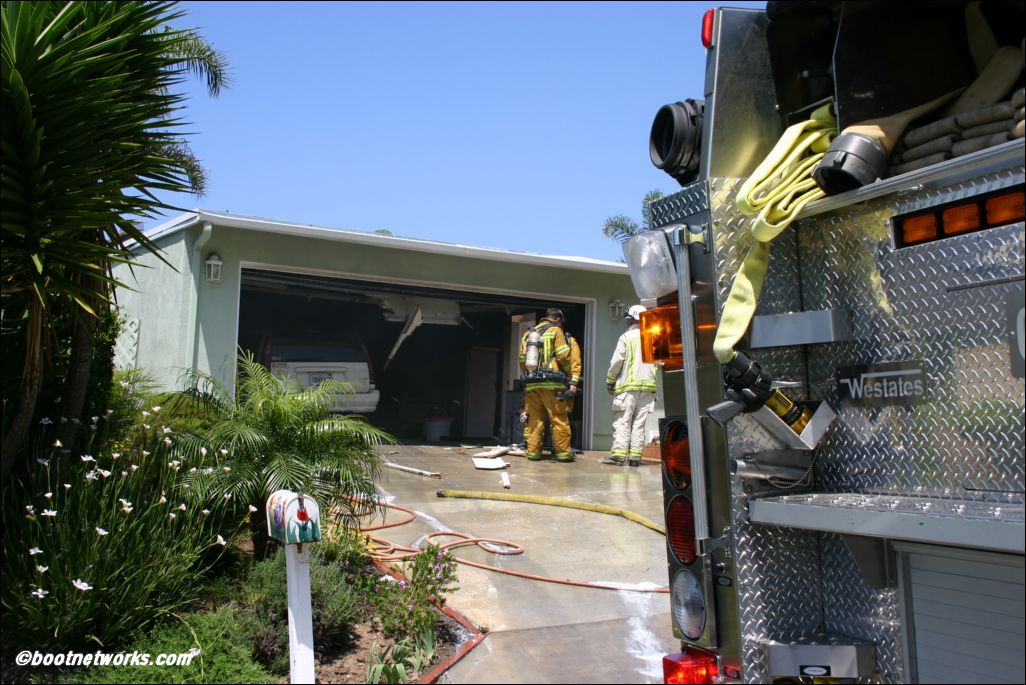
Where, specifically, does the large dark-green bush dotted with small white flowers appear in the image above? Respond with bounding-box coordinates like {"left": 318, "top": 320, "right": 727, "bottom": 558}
{"left": 0, "top": 380, "right": 241, "bottom": 650}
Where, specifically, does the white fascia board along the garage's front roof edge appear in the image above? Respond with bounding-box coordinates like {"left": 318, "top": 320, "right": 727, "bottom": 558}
{"left": 140, "top": 209, "right": 628, "bottom": 276}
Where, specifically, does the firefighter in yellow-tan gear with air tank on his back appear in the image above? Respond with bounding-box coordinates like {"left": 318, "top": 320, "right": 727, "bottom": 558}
{"left": 520, "top": 309, "right": 574, "bottom": 461}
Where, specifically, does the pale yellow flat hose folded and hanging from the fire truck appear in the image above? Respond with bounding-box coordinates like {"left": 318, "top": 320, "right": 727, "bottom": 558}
{"left": 713, "top": 104, "right": 837, "bottom": 364}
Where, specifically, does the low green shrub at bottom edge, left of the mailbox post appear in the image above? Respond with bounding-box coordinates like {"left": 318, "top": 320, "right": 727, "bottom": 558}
{"left": 53, "top": 606, "right": 279, "bottom": 683}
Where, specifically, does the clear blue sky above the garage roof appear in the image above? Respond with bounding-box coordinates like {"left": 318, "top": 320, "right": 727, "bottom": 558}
{"left": 160, "top": 2, "right": 764, "bottom": 260}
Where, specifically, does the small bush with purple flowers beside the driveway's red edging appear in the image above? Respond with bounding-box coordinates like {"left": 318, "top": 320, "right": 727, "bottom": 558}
{"left": 370, "top": 545, "right": 457, "bottom": 638}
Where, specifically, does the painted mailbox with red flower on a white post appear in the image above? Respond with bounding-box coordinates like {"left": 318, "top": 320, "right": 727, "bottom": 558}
{"left": 267, "top": 490, "right": 320, "bottom": 683}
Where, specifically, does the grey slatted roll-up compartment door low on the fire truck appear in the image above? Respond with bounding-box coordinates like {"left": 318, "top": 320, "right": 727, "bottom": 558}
{"left": 894, "top": 542, "right": 1026, "bottom": 683}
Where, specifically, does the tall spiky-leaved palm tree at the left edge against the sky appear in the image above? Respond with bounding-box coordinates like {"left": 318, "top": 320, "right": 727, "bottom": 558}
{"left": 0, "top": 0, "right": 227, "bottom": 482}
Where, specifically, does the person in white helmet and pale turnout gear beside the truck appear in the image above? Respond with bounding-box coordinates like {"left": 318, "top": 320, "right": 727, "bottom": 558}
{"left": 602, "top": 305, "right": 656, "bottom": 467}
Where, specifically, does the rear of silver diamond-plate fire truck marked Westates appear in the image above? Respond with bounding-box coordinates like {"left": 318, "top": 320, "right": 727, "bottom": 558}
{"left": 624, "top": 1, "right": 1026, "bottom": 683}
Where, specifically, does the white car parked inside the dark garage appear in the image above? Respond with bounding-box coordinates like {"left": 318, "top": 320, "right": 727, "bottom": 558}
{"left": 259, "top": 334, "right": 381, "bottom": 414}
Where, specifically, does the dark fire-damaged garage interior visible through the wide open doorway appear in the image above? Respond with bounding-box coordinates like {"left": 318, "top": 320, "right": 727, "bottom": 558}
{"left": 232, "top": 269, "right": 591, "bottom": 449}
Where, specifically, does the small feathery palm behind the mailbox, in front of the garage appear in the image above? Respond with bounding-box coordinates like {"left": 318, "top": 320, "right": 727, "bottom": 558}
{"left": 179, "top": 350, "right": 394, "bottom": 558}
